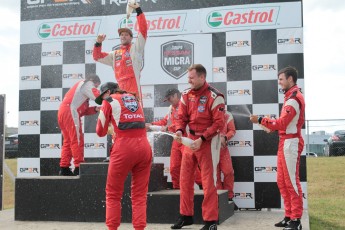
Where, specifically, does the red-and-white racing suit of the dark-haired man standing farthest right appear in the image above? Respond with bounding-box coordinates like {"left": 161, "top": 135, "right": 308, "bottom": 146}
{"left": 260, "top": 85, "right": 305, "bottom": 219}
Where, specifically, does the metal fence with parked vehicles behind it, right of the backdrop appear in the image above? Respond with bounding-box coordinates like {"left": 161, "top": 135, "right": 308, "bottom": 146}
{"left": 304, "top": 119, "right": 345, "bottom": 156}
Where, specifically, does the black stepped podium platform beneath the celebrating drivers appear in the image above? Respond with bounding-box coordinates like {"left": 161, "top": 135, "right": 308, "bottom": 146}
{"left": 15, "top": 162, "right": 234, "bottom": 224}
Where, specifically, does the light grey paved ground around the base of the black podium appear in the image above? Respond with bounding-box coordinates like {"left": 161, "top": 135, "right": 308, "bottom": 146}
{"left": 0, "top": 209, "right": 309, "bottom": 230}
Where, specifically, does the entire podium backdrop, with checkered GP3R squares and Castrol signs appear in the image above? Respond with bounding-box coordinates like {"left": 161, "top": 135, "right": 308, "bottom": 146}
{"left": 18, "top": 0, "right": 307, "bottom": 208}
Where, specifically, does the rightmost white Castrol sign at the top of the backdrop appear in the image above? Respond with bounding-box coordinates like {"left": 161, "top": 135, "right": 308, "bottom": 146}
{"left": 200, "top": 2, "right": 302, "bottom": 33}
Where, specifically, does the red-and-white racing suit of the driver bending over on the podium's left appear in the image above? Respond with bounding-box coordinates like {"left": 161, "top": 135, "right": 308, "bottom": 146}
{"left": 58, "top": 81, "right": 99, "bottom": 167}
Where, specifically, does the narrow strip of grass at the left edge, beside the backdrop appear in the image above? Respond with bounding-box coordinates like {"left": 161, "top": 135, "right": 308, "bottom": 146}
{"left": 3, "top": 159, "right": 17, "bottom": 209}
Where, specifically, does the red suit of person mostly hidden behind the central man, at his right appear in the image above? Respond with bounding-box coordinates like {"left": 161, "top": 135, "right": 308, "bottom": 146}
{"left": 217, "top": 111, "right": 236, "bottom": 199}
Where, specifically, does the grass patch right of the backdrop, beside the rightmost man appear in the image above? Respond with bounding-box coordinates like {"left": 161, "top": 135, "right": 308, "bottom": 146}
{"left": 307, "top": 157, "right": 345, "bottom": 230}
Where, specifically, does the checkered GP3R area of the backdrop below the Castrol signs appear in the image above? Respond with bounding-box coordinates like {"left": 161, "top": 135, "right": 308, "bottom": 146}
{"left": 18, "top": 1, "right": 307, "bottom": 209}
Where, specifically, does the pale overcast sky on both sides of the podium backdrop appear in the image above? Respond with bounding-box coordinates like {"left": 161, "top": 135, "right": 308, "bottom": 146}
{"left": 0, "top": 0, "right": 345, "bottom": 133}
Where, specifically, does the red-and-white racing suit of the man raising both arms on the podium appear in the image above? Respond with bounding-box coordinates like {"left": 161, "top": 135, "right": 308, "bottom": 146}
{"left": 93, "top": 13, "right": 147, "bottom": 98}
